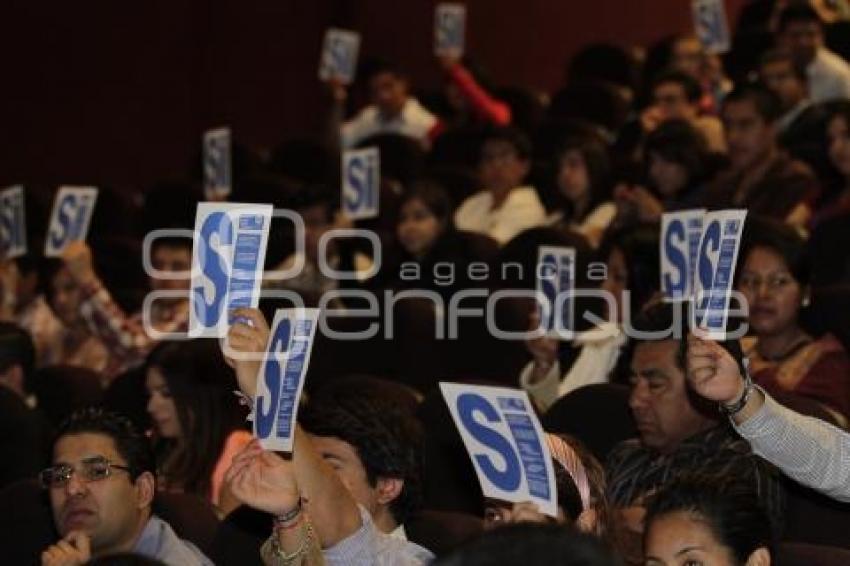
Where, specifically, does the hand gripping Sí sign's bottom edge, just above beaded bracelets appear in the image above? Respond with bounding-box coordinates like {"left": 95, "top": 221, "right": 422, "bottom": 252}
{"left": 224, "top": 439, "right": 301, "bottom": 515}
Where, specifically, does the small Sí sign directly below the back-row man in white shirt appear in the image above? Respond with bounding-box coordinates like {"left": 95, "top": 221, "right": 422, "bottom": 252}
{"left": 342, "top": 147, "right": 381, "bottom": 220}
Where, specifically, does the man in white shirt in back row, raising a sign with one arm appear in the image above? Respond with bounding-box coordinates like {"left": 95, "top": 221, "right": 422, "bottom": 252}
{"left": 331, "top": 61, "right": 440, "bottom": 148}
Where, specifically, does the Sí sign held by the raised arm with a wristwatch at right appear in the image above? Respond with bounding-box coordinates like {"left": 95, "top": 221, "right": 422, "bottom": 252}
{"left": 694, "top": 210, "right": 747, "bottom": 340}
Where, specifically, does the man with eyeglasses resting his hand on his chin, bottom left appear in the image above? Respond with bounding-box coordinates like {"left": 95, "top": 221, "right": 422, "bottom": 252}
{"left": 40, "top": 409, "right": 212, "bottom": 566}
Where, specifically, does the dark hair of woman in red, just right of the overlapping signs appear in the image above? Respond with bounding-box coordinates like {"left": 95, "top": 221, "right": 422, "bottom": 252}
{"left": 738, "top": 216, "right": 809, "bottom": 286}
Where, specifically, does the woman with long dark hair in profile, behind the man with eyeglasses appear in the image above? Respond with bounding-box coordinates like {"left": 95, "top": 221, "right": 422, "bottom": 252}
{"left": 145, "top": 340, "right": 251, "bottom": 516}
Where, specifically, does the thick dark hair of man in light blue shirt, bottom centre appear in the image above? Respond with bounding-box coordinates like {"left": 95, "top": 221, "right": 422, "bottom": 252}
{"left": 298, "top": 395, "right": 423, "bottom": 524}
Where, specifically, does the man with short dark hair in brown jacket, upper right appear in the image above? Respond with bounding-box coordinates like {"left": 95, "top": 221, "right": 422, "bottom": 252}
{"left": 706, "top": 84, "right": 820, "bottom": 228}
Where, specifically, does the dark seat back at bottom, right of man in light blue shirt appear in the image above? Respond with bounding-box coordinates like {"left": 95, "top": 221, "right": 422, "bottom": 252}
{"left": 404, "top": 510, "right": 484, "bottom": 557}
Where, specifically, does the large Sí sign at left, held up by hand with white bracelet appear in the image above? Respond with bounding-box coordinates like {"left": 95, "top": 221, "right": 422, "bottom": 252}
{"left": 189, "top": 202, "right": 273, "bottom": 338}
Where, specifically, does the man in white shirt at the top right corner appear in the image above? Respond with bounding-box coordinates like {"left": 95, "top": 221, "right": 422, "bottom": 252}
{"left": 779, "top": 4, "right": 850, "bottom": 102}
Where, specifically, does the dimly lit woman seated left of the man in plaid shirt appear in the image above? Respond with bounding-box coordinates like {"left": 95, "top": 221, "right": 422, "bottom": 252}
{"left": 43, "top": 260, "right": 109, "bottom": 378}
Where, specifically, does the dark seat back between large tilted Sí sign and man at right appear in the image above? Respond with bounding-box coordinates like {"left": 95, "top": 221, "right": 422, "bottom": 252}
{"left": 541, "top": 383, "right": 638, "bottom": 463}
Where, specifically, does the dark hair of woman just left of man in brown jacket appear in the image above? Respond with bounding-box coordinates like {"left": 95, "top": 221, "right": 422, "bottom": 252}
{"left": 644, "top": 120, "right": 710, "bottom": 192}
